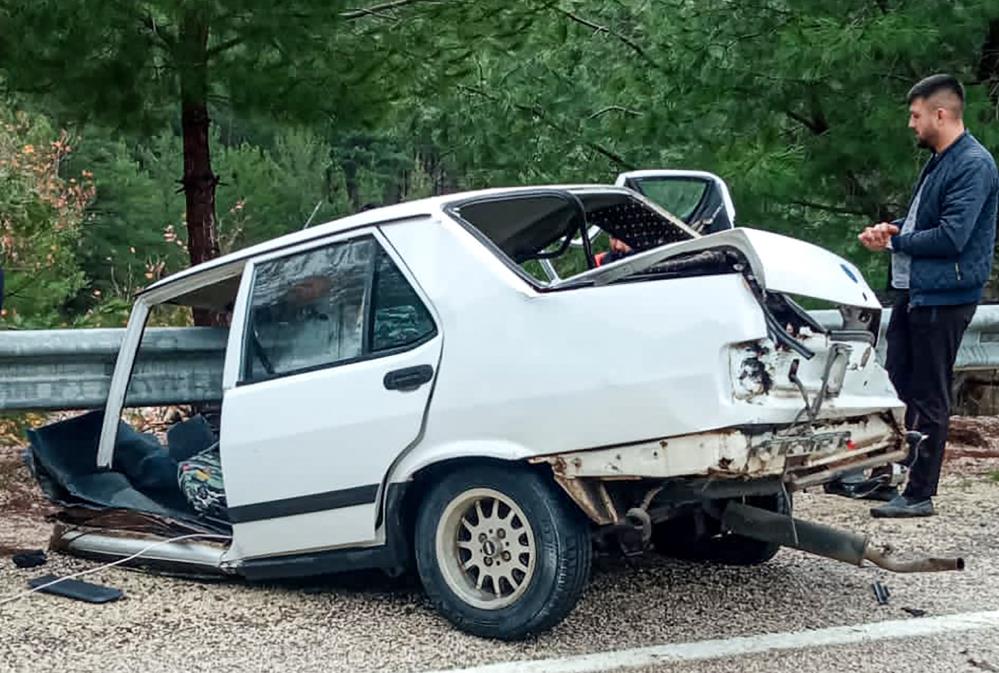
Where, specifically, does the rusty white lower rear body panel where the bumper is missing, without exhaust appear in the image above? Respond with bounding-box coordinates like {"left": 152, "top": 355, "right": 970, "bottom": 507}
{"left": 532, "top": 414, "right": 907, "bottom": 525}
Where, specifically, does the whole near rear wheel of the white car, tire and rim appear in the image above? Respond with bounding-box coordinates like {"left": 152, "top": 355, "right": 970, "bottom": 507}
{"left": 414, "top": 465, "right": 592, "bottom": 640}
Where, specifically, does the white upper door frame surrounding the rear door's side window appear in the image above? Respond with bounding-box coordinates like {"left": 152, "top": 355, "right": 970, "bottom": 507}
{"left": 233, "top": 227, "right": 441, "bottom": 387}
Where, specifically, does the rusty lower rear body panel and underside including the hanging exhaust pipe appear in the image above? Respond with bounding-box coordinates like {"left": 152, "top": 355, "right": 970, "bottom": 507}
{"left": 532, "top": 414, "right": 964, "bottom": 572}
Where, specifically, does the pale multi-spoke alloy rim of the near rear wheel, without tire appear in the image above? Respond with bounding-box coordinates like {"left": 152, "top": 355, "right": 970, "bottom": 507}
{"left": 435, "top": 488, "right": 537, "bottom": 610}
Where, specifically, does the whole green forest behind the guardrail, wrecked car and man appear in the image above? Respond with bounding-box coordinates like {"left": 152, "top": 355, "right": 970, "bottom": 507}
{"left": 0, "top": 0, "right": 999, "bottom": 329}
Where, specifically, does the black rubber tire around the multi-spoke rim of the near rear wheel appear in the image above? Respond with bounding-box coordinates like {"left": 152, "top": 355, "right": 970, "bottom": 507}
{"left": 414, "top": 464, "right": 592, "bottom": 640}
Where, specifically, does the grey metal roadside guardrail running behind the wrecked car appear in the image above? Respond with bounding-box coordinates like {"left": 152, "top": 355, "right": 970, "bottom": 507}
{"left": 0, "top": 305, "right": 999, "bottom": 411}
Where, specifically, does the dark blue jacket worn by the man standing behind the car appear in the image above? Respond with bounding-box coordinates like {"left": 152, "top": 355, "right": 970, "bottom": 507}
{"left": 891, "top": 131, "right": 999, "bottom": 306}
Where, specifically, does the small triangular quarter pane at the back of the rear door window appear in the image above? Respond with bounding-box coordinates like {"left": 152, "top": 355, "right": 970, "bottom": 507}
{"left": 371, "top": 249, "right": 437, "bottom": 353}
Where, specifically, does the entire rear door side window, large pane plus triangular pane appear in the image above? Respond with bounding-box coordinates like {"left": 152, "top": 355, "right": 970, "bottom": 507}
{"left": 242, "top": 237, "right": 436, "bottom": 383}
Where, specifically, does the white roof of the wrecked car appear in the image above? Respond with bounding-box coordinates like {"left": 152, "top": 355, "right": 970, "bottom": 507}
{"left": 139, "top": 184, "right": 632, "bottom": 295}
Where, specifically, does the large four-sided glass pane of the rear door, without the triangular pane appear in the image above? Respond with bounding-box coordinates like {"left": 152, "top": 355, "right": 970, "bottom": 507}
{"left": 243, "top": 238, "right": 376, "bottom": 382}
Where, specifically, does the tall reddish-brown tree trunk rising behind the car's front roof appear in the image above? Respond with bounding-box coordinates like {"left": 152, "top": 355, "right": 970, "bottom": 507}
{"left": 178, "top": 9, "right": 219, "bottom": 325}
